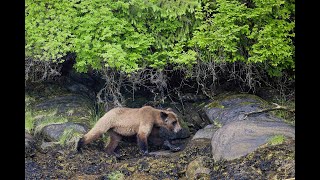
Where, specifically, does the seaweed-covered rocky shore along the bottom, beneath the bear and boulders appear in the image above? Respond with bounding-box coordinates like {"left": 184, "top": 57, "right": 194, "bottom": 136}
{"left": 25, "top": 139, "right": 295, "bottom": 180}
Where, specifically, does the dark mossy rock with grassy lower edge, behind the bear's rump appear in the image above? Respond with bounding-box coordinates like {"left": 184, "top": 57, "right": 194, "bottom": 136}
{"left": 25, "top": 82, "right": 96, "bottom": 129}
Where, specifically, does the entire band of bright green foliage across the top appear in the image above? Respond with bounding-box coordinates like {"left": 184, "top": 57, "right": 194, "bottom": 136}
{"left": 25, "top": 0, "right": 295, "bottom": 76}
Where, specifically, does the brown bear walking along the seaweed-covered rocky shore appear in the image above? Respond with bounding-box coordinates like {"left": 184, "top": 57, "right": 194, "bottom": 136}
{"left": 79, "top": 106, "right": 181, "bottom": 154}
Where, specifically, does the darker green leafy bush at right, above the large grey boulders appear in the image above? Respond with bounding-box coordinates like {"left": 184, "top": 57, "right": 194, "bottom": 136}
{"left": 190, "top": 0, "right": 295, "bottom": 76}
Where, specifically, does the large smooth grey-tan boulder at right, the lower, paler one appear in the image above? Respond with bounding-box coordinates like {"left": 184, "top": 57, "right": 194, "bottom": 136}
{"left": 211, "top": 120, "right": 295, "bottom": 161}
